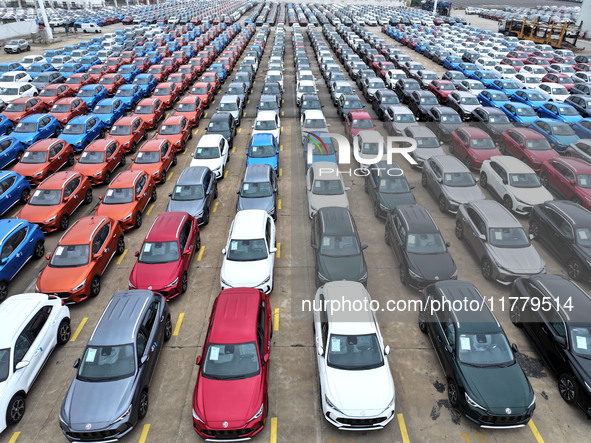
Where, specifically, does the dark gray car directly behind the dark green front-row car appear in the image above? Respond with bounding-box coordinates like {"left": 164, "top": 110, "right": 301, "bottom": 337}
{"left": 384, "top": 204, "right": 458, "bottom": 290}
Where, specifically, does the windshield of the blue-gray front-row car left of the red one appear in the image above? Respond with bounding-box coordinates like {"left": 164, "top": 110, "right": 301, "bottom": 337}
{"left": 77, "top": 346, "right": 139, "bottom": 382}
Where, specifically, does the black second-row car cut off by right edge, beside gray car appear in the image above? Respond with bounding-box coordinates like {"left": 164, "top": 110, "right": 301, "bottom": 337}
{"left": 529, "top": 200, "right": 591, "bottom": 281}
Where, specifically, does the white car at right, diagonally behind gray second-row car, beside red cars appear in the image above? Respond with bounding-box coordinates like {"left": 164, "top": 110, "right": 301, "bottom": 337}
{"left": 480, "top": 155, "right": 554, "bottom": 215}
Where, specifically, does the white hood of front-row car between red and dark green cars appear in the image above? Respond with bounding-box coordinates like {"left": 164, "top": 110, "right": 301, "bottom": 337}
{"left": 326, "top": 364, "right": 394, "bottom": 416}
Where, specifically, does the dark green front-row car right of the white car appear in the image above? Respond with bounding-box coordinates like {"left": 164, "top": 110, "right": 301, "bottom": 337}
{"left": 419, "top": 280, "right": 536, "bottom": 428}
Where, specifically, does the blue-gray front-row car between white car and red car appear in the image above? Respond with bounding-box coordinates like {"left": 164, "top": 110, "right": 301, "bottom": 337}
{"left": 59, "top": 290, "right": 172, "bottom": 441}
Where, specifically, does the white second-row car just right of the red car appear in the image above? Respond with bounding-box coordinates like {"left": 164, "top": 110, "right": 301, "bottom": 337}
{"left": 220, "top": 209, "right": 277, "bottom": 294}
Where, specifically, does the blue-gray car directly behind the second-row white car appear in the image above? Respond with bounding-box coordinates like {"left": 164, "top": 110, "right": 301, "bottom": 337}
{"left": 236, "top": 163, "right": 278, "bottom": 220}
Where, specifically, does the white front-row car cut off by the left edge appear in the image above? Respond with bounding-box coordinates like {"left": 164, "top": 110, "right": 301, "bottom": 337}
{"left": 0, "top": 294, "right": 71, "bottom": 432}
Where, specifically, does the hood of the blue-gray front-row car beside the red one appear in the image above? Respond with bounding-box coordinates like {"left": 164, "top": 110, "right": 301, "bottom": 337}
{"left": 62, "top": 377, "right": 134, "bottom": 431}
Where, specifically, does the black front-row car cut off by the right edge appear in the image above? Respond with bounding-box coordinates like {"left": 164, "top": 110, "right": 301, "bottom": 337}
{"left": 510, "top": 274, "right": 591, "bottom": 418}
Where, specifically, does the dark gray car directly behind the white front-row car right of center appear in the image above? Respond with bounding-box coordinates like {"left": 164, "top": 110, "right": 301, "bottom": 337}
{"left": 312, "top": 206, "right": 367, "bottom": 287}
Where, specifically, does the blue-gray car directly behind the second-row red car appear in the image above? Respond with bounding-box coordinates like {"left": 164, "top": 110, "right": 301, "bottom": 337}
{"left": 166, "top": 166, "right": 218, "bottom": 226}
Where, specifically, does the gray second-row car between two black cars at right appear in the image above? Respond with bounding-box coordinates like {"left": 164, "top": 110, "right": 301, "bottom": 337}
{"left": 456, "top": 200, "right": 546, "bottom": 285}
